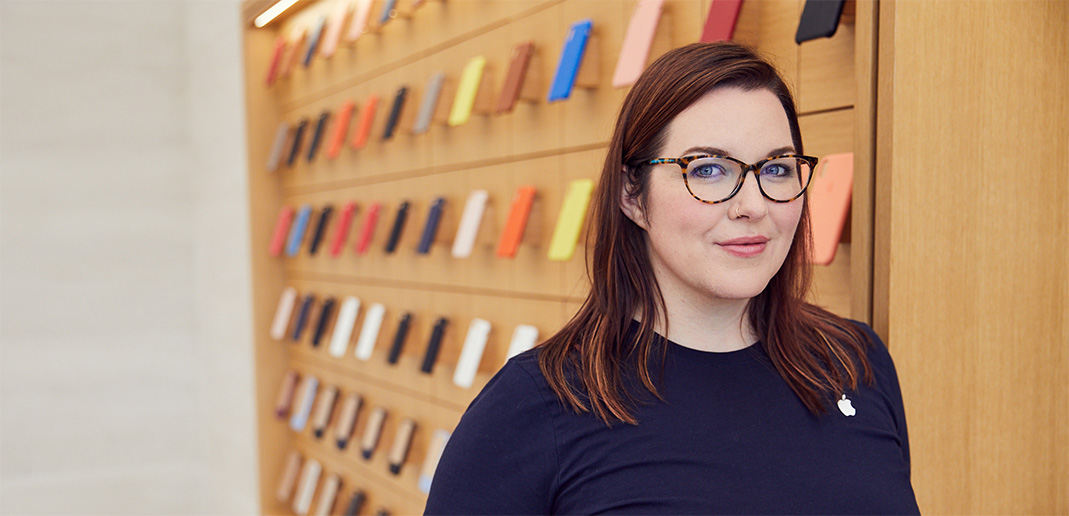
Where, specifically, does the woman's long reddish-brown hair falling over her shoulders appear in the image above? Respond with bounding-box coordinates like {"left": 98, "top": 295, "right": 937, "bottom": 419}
{"left": 539, "top": 43, "right": 872, "bottom": 424}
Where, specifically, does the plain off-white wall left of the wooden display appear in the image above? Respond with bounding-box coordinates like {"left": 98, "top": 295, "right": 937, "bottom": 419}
{"left": 0, "top": 0, "right": 257, "bottom": 514}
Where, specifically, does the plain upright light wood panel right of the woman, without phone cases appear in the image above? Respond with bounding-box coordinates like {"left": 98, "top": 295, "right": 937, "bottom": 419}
{"left": 874, "top": 1, "right": 1069, "bottom": 514}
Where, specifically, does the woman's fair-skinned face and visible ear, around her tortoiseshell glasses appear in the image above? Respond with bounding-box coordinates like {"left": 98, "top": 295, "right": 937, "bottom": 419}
{"left": 622, "top": 88, "right": 803, "bottom": 303}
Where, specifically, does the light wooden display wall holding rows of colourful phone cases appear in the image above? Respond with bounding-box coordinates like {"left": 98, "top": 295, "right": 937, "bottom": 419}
{"left": 244, "top": 0, "right": 871, "bottom": 514}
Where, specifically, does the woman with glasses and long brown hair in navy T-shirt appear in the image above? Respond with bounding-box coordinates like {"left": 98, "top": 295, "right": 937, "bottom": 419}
{"left": 427, "top": 43, "right": 918, "bottom": 514}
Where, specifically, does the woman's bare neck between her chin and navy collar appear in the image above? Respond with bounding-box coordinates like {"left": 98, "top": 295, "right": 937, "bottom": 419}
{"left": 636, "top": 295, "right": 757, "bottom": 353}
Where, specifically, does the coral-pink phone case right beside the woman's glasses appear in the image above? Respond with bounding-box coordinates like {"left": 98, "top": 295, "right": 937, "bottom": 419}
{"left": 806, "top": 153, "right": 854, "bottom": 265}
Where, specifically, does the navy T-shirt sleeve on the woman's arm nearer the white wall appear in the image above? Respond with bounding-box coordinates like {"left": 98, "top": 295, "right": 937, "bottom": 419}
{"left": 424, "top": 354, "right": 557, "bottom": 515}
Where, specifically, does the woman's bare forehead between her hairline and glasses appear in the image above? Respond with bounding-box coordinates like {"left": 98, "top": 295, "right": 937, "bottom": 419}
{"left": 662, "top": 88, "right": 793, "bottom": 162}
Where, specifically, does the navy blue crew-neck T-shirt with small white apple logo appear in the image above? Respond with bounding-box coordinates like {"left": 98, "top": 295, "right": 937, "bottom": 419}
{"left": 425, "top": 326, "right": 918, "bottom": 514}
